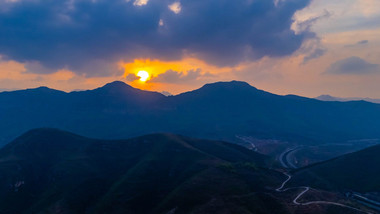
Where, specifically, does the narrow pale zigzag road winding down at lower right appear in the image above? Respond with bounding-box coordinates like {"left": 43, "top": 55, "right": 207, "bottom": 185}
{"left": 276, "top": 172, "right": 373, "bottom": 214}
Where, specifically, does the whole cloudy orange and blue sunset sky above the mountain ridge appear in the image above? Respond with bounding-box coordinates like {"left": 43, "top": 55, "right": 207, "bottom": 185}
{"left": 0, "top": 0, "right": 380, "bottom": 98}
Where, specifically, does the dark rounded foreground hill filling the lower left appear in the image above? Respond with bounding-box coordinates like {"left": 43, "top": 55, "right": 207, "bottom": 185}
{"left": 0, "top": 129, "right": 292, "bottom": 214}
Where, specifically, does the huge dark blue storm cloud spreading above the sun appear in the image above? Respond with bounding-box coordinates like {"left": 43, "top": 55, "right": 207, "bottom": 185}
{"left": 0, "top": 0, "right": 315, "bottom": 75}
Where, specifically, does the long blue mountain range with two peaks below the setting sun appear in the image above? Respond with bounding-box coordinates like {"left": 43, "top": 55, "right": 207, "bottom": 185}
{"left": 0, "top": 81, "right": 380, "bottom": 145}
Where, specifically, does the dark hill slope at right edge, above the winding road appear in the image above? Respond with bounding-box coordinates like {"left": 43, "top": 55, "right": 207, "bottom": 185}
{"left": 293, "top": 145, "right": 380, "bottom": 193}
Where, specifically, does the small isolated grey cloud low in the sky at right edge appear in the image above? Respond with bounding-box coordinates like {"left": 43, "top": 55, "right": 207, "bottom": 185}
{"left": 326, "top": 56, "right": 380, "bottom": 75}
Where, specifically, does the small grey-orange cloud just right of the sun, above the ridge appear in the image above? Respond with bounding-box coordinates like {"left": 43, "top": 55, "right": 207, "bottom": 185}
{"left": 149, "top": 69, "right": 212, "bottom": 84}
